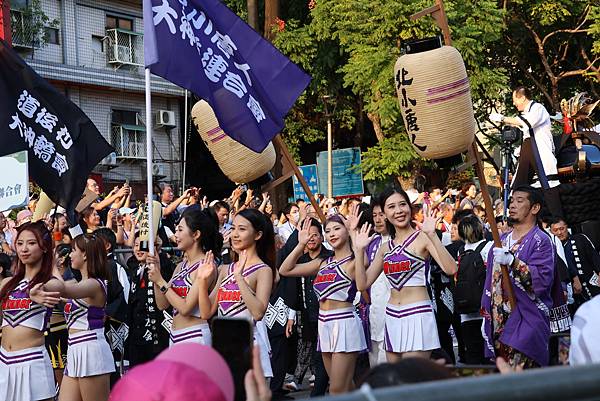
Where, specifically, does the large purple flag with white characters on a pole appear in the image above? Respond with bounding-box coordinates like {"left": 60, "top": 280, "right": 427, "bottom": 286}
{"left": 144, "top": 0, "right": 310, "bottom": 152}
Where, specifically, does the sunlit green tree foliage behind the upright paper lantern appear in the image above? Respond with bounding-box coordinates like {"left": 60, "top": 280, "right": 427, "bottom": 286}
{"left": 275, "top": 0, "right": 507, "bottom": 179}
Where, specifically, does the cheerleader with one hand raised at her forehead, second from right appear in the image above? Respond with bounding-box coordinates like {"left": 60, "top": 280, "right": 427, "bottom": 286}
{"left": 280, "top": 215, "right": 367, "bottom": 394}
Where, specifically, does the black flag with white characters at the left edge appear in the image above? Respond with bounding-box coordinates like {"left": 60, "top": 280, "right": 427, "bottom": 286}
{"left": 0, "top": 40, "right": 113, "bottom": 219}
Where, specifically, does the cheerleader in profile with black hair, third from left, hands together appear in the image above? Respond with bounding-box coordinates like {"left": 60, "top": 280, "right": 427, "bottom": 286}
{"left": 146, "top": 208, "right": 223, "bottom": 345}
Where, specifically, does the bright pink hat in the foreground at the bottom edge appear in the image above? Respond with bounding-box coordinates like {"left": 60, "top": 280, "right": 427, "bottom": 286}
{"left": 109, "top": 343, "right": 234, "bottom": 401}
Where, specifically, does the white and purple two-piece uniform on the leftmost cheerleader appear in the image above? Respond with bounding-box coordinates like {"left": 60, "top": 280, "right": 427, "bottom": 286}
{"left": 0, "top": 279, "right": 56, "bottom": 401}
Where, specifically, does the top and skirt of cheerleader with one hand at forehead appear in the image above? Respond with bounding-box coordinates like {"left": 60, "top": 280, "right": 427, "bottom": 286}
{"left": 313, "top": 256, "right": 367, "bottom": 352}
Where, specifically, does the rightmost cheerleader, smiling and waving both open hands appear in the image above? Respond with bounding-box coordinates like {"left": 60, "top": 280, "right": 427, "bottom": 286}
{"left": 354, "top": 189, "right": 457, "bottom": 362}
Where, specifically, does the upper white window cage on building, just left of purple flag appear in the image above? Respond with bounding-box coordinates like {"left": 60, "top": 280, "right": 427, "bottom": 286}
{"left": 105, "top": 29, "right": 144, "bottom": 68}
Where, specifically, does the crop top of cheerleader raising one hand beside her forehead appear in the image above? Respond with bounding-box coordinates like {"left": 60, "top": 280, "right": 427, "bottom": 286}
{"left": 313, "top": 255, "right": 356, "bottom": 302}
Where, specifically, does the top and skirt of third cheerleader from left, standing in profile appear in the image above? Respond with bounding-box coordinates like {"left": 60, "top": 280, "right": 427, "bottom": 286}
{"left": 169, "top": 260, "right": 212, "bottom": 345}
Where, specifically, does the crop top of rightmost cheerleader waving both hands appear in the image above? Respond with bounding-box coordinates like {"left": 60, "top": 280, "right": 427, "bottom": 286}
{"left": 383, "top": 231, "right": 429, "bottom": 290}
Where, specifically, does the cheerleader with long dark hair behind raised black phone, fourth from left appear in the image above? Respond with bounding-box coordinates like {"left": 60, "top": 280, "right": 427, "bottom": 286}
{"left": 197, "top": 209, "right": 276, "bottom": 377}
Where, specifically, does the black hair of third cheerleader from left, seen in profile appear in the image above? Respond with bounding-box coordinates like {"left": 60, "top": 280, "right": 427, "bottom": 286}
{"left": 181, "top": 208, "right": 223, "bottom": 258}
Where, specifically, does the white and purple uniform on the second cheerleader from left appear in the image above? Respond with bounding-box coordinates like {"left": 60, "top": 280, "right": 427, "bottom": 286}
{"left": 65, "top": 278, "right": 115, "bottom": 377}
